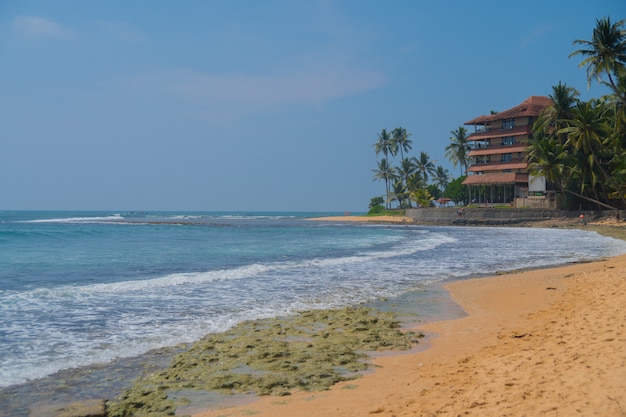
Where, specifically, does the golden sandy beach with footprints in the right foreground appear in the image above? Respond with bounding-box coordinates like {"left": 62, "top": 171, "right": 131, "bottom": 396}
{"left": 195, "top": 249, "right": 626, "bottom": 417}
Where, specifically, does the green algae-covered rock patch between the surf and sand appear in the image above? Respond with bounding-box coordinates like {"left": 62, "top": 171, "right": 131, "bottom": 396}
{"left": 108, "top": 307, "right": 422, "bottom": 417}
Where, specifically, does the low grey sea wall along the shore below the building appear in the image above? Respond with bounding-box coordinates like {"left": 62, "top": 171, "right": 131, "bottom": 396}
{"left": 405, "top": 208, "right": 624, "bottom": 226}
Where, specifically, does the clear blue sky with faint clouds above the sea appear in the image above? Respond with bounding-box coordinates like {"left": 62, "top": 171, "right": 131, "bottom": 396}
{"left": 0, "top": 0, "right": 626, "bottom": 212}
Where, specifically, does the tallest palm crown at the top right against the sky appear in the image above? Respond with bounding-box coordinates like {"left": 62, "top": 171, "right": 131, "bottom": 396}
{"left": 569, "top": 17, "right": 626, "bottom": 104}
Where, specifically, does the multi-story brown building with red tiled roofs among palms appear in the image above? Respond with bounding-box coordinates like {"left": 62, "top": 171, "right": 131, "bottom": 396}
{"left": 463, "top": 96, "right": 556, "bottom": 208}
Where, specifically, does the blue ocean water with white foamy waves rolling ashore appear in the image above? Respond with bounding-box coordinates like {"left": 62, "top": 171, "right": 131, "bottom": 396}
{"left": 0, "top": 211, "right": 626, "bottom": 406}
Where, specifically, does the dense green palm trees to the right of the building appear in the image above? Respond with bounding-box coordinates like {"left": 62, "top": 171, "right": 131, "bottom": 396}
{"left": 527, "top": 17, "right": 626, "bottom": 209}
